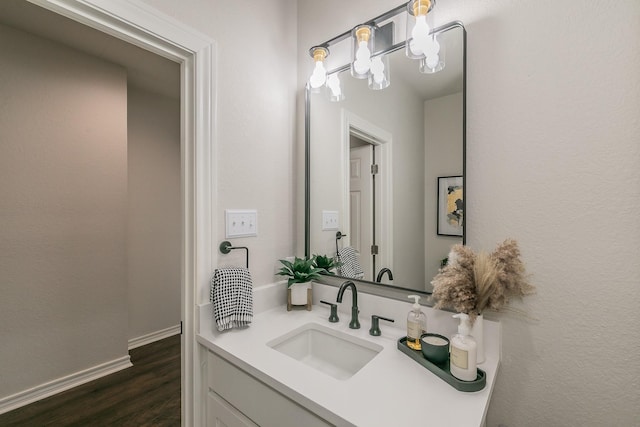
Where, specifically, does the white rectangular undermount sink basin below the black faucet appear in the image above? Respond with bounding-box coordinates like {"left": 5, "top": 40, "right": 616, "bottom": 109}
{"left": 267, "top": 323, "right": 382, "bottom": 380}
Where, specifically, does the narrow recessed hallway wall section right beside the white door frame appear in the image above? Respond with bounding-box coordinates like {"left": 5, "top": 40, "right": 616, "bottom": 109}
{"left": 127, "top": 86, "right": 182, "bottom": 340}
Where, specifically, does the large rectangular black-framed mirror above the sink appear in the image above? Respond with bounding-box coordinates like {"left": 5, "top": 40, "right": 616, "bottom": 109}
{"left": 305, "top": 22, "right": 467, "bottom": 293}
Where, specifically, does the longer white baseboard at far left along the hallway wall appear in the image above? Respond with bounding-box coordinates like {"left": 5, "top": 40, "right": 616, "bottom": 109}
{"left": 0, "top": 355, "right": 133, "bottom": 414}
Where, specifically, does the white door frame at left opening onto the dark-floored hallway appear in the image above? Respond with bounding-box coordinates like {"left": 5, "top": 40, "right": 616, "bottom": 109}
{"left": 28, "top": 0, "right": 216, "bottom": 426}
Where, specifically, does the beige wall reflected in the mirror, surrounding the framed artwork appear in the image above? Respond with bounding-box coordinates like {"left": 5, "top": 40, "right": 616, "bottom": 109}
{"left": 424, "top": 92, "right": 463, "bottom": 291}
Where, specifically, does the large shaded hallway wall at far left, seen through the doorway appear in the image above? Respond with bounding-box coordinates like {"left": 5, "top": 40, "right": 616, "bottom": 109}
{"left": 0, "top": 26, "right": 127, "bottom": 397}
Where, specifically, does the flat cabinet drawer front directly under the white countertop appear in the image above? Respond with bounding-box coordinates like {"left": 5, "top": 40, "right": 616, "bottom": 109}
{"left": 207, "top": 352, "right": 333, "bottom": 427}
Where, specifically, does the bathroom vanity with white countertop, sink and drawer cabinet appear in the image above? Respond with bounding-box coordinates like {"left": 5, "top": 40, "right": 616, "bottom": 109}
{"left": 197, "top": 283, "right": 500, "bottom": 427}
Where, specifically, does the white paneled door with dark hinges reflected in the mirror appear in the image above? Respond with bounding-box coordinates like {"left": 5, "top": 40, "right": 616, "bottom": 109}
{"left": 349, "top": 144, "right": 375, "bottom": 280}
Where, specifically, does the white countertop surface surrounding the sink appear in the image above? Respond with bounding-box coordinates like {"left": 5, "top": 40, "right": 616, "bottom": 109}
{"left": 197, "top": 284, "right": 500, "bottom": 427}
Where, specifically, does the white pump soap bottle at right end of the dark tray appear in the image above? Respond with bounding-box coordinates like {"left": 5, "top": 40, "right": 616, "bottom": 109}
{"left": 449, "top": 313, "right": 478, "bottom": 381}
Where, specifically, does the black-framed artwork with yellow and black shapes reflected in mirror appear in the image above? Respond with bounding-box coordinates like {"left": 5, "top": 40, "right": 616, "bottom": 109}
{"left": 438, "top": 176, "right": 464, "bottom": 237}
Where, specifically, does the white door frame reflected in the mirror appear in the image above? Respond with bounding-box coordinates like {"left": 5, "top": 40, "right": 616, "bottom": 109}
{"left": 340, "top": 108, "right": 393, "bottom": 281}
